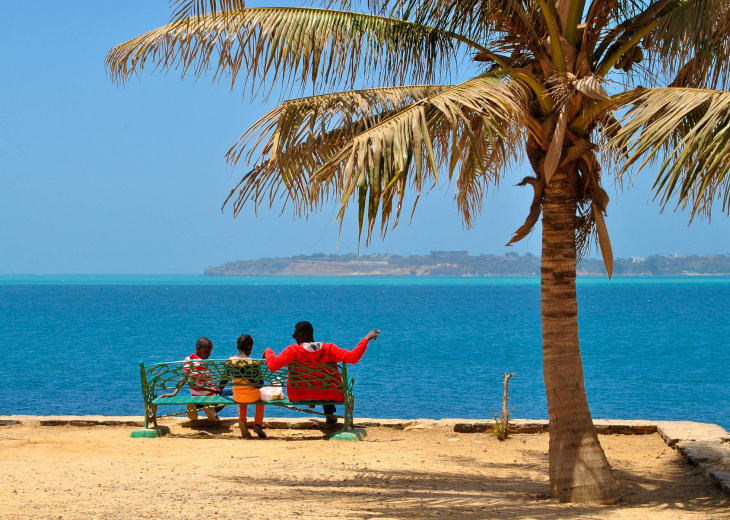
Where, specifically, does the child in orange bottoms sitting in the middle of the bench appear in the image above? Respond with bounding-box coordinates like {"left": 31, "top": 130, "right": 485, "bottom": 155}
{"left": 227, "top": 334, "right": 266, "bottom": 439}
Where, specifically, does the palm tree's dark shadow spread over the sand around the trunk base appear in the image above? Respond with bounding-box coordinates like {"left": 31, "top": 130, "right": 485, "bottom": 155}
{"left": 216, "top": 457, "right": 730, "bottom": 519}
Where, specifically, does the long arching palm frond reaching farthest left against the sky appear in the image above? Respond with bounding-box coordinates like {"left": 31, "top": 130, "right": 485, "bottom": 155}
{"left": 106, "top": 8, "right": 484, "bottom": 94}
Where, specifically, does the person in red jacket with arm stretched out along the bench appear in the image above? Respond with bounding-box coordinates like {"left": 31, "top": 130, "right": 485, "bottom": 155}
{"left": 264, "top": 321, "right": 380, "bottom": 425}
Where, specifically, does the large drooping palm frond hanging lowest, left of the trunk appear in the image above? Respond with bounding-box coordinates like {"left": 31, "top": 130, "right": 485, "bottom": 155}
{"left": 225, "top": 74, "right": 526, "bottom": 239}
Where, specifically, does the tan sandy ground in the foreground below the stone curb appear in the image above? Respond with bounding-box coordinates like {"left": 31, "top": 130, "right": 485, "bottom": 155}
{"left": 0, "top": 421, "right": 730, "bottom": 519}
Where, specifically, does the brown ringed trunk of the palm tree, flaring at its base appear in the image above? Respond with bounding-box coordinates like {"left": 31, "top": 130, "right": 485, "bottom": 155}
{"left": 540, "top": 172, "right": 621, "bottom": 504}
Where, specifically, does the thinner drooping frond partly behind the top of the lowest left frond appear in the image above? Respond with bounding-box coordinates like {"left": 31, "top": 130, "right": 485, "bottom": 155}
{"left": 223, "top": 85, "right": 440, "bottom": 216}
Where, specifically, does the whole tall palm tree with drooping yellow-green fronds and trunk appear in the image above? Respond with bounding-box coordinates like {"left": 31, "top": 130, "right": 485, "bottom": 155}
{"left": 107, "top": 0, "right": 730, "bottom": 504}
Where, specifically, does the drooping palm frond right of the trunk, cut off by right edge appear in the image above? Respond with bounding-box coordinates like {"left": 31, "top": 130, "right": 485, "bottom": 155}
{"left": 609, "top": 88, "right": 730, "bottom": 219}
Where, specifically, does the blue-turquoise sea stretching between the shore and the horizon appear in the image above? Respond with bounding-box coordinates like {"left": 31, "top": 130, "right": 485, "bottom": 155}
{"left": 0, "top": 275, "right": 730, "bottom": 429}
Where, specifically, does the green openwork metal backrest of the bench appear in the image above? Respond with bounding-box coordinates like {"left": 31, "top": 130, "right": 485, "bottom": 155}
{"left": 140, "top": 359, "right": 347, "bottom": 395}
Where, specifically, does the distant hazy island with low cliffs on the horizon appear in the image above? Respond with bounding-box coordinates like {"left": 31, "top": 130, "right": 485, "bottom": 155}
{"left": 204, "top": 251, "right": 730, "bottom": 276}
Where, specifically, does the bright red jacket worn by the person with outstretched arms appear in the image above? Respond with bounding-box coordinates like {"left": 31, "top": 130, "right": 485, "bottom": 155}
{"left": 264, "top": 338, "right": 368, "bottom": 401}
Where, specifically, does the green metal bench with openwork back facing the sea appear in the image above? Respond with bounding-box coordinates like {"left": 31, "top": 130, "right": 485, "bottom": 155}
{"left": 132, "top": 359, "right": 366, "bottom": 440}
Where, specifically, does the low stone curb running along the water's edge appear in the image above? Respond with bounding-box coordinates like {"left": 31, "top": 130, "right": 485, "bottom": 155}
{"left": 0, "top": 415, "right": 730, "bottom": 494}
